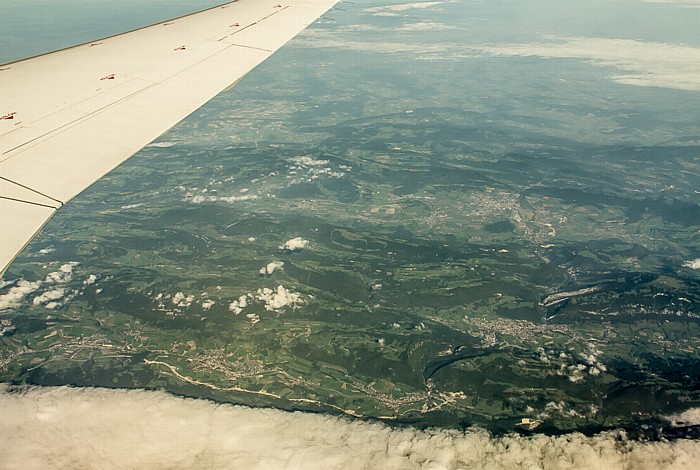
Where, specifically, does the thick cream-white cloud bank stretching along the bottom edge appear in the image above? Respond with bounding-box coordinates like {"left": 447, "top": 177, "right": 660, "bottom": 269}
{"left": 0, "top": 387, "right": 700, "bottom": 470}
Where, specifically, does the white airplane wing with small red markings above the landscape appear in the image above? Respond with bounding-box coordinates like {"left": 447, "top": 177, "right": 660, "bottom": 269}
{"left": 0, "top": 0, "right": 337, "bottom": 275}
